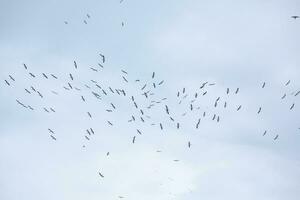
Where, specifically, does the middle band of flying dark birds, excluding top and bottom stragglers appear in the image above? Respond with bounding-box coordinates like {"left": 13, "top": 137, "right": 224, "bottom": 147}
{"left": 4, "top": 54, "right": 300, "bottom": 143}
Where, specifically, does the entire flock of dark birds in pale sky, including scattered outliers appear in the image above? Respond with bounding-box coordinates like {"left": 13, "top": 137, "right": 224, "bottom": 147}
{"left": 4, "top": 6, "right": 300, "bottom": 198}
